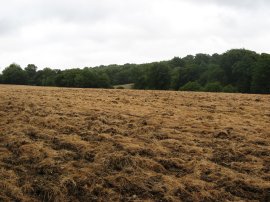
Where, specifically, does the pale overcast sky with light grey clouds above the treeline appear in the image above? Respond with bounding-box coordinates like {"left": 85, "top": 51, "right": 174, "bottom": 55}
{"left": 0, "top": 0, "right": 270, "bottom": 71}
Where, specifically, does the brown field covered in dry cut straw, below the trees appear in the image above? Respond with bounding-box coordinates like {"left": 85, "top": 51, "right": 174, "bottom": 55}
{"left": 0, "top": 85, "right": 270, "bottom": 202}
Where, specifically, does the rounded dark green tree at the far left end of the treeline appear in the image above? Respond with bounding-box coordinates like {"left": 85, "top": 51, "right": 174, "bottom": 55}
{"left": 2, "top": 63, "right": 27, "bottom": 84}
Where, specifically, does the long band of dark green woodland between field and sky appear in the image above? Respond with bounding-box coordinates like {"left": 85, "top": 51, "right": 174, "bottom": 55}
{"left": 0, "top": 49, "right": 270, "bottom": 94}
